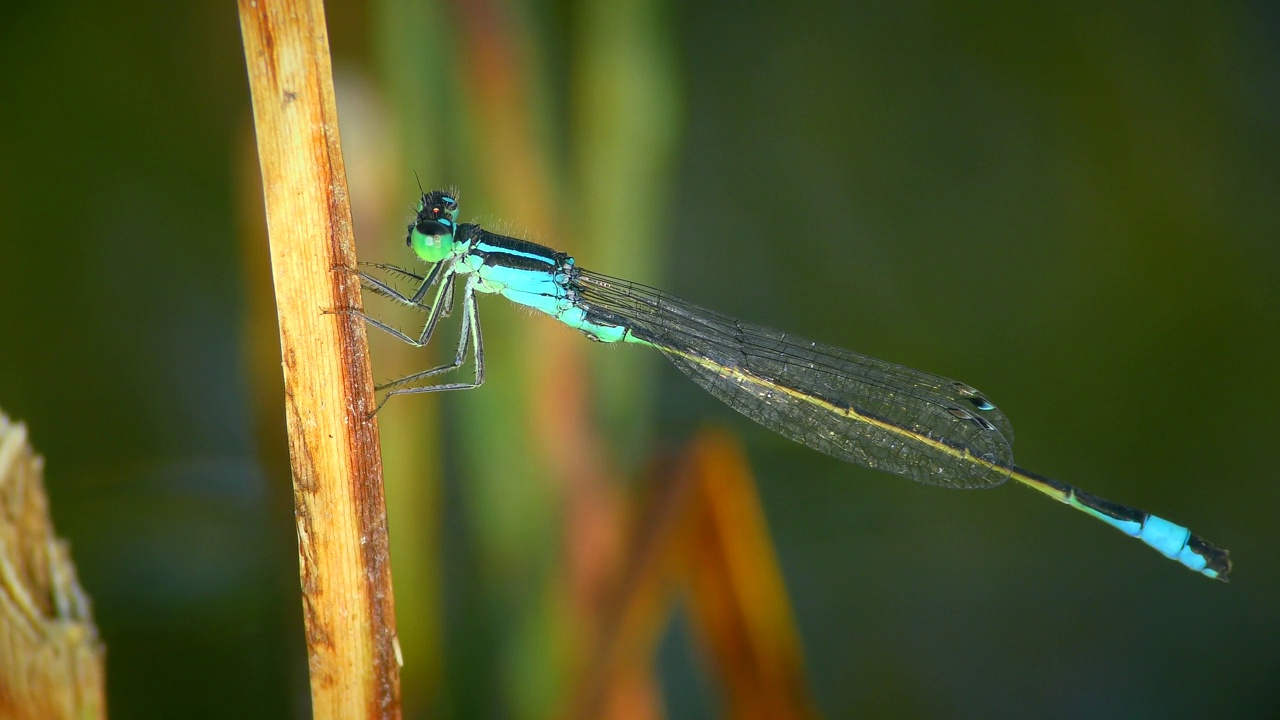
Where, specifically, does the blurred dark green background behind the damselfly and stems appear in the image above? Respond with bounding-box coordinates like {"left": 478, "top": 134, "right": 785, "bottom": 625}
{"left": 0, "top": 0, "right": 1280, "bottom": 717}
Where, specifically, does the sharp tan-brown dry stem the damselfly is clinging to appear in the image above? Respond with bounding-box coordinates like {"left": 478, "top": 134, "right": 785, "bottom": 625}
{"left": 238, "top": 0, "right": 401, "bottom": 719}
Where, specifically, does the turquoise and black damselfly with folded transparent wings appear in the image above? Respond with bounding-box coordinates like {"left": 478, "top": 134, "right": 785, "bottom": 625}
{"left": 350, "top": 191, "right": 1231, "bottom": 580}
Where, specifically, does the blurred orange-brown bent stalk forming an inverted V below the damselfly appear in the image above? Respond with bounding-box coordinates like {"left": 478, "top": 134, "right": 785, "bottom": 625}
{"left": 570, "top": 430, "right": 817, "bottom": 719}
